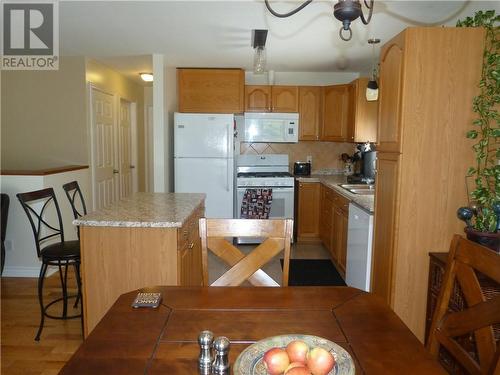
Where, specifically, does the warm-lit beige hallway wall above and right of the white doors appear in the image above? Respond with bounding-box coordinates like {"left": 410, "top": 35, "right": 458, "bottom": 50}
{"left": 86, "top": 59, "right": 145, "bottom": 191}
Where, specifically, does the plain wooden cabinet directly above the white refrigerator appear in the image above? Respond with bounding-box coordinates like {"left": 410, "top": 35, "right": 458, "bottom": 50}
{"left": 177, "top": 68, "right": 245, "bottom": 113}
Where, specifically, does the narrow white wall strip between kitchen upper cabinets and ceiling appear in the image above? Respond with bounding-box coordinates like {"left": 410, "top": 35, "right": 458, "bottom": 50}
{"left": 245, "top": 71, "right": 359, "bottom": 86}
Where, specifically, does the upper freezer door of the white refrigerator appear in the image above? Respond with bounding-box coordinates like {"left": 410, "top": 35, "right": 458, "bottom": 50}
{"left": 174, "top": 113, "right": 234, "bottom": 158}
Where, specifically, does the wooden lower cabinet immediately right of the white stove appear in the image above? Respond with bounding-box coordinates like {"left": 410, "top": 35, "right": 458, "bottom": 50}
{"left": 297, "top": 182, "right": 321, "bottom": 241}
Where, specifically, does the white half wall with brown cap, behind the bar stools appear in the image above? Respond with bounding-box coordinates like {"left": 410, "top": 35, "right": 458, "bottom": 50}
{"left": 0, "top": 169, "right": 91, "bottom": 277}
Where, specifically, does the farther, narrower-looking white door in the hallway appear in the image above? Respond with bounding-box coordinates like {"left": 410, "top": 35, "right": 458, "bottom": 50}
{"left": 118, "top": 99, "right": 134, "bottom": 199}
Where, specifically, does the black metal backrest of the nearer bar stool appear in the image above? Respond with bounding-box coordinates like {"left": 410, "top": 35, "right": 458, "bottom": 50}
{"left": 16, "top": 188, "right": 64, "bottom": 257}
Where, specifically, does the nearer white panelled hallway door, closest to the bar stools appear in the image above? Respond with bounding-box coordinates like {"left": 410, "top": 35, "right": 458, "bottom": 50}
{"left": 91, "top": 88, "right": 117, "bottom": 210}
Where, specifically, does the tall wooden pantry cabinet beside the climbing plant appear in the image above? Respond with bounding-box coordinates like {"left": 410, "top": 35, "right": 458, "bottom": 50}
{"left": 372, "top": 27, "right": 484, "bottom": 340}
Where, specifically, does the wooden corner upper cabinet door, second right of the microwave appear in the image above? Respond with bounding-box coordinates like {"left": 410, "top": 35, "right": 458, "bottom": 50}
{"left": 320, "top": 85, "right": 349, "bottom": 142}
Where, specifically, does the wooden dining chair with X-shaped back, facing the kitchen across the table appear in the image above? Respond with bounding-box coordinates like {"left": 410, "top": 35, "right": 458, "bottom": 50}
{"left": 200, "top": 218, "right": 293, "bottom": 286}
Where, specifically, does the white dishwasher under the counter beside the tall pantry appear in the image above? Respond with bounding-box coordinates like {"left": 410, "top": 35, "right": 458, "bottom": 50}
{"left": 346, "top": 203, "right": 373, "bottom": 292}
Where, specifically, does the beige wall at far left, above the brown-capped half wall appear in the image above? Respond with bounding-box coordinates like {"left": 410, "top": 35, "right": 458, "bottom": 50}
{"left": 0, "top": 57, "right": 88, "bottom": 169}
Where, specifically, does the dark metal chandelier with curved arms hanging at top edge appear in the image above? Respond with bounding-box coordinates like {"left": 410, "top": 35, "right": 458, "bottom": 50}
{"left": 264, "top": 0, "right": 375, "bottom": 42}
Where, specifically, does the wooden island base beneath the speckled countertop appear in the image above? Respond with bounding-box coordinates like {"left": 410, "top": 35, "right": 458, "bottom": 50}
{"left": 80, "top": 206, "right": 205, "bottom": 337}
